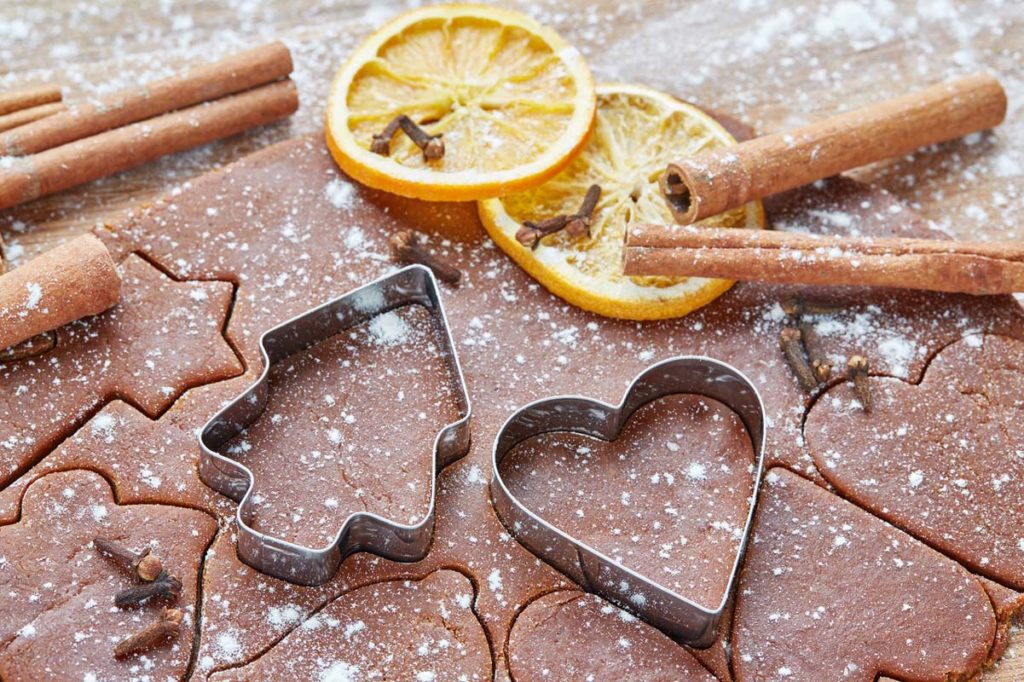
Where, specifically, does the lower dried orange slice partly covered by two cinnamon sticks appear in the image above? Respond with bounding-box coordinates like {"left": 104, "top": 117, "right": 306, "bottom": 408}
{"left": 478, "top": 85, "right": 765, "bottom": 319}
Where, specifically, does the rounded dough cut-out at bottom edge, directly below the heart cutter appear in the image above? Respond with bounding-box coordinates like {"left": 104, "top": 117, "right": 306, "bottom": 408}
{"left": 508, "top": 590, "right": 715, "bottom": 682}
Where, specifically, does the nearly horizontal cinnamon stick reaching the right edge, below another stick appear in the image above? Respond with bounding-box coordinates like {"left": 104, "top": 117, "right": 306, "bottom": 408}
{"left": 625, "top": 225, "right": 1024, "bottom": 294}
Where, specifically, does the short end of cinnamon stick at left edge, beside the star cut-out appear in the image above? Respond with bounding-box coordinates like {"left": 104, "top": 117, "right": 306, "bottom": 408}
{"left": 0, "top": 235, "right": 121, "bottom": 349}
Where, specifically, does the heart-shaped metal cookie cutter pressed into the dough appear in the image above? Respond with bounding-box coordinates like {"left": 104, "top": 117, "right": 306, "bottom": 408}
{"left": 490, "top": 356, "right": 766, "bottom": 648}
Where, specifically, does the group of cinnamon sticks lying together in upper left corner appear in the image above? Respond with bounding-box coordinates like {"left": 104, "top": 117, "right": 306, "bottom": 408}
{"left": 0, "top": 42, "right": 298, "bottom": 209}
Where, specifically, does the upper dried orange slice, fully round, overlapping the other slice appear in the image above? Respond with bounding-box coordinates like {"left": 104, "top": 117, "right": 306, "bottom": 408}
{"left": 326, "top": 5, "right": 596, "bottom": 201}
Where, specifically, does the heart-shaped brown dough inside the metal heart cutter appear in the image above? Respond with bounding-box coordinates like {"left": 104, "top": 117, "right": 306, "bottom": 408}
{"left": 502, "top": 395, "right": 755, "bottom": 610}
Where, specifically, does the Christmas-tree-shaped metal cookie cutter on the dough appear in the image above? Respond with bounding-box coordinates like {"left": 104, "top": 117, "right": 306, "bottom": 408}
{"left": 199, "top": 265, "right": 470, "bottom": 585}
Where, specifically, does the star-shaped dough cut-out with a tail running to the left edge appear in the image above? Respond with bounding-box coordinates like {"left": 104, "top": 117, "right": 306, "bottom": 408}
{"left": 0, "top": 251, "right": 242, "bottom": 485}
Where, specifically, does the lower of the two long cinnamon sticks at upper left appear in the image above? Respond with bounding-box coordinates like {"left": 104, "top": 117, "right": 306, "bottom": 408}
{"left": 0, "top": 79, "right": 299, "bottom": 208}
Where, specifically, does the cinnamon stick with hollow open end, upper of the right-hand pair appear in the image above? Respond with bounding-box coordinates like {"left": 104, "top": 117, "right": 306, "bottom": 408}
{"left": 660, "top": 74, "right": 1007, "bottom": 224}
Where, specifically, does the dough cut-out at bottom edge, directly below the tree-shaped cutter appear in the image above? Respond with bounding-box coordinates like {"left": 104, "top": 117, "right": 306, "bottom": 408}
{"left": 206, "top": 570, "right": 492, "bottom": 682}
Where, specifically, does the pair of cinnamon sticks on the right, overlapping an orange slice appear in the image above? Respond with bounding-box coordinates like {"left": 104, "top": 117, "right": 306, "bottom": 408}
{"left": 625, "top": 74, "right": 1024, "bottom": 294}
